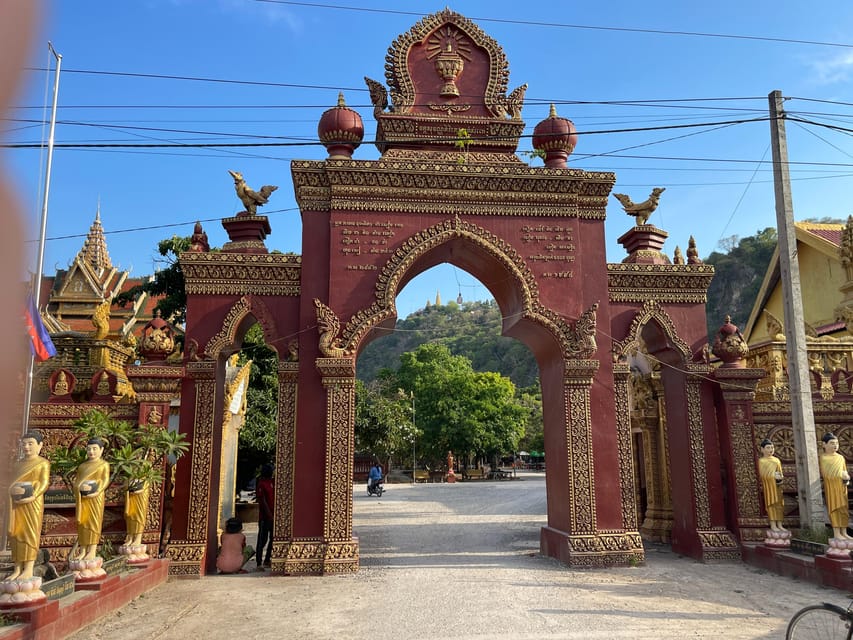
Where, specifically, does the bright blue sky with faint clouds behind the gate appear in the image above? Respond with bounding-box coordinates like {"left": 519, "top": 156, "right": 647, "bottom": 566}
{"left": 2, "top": 0, "right": 853, "bottom": 316}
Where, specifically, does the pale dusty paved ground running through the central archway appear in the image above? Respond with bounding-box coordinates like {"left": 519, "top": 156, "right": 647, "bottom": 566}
{"left": 68, "top": 475, "right": 847, "bottom": 640}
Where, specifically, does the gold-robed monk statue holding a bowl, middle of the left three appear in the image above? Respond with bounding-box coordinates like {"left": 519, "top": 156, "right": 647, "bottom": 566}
{"left": 74, "top": 440, "right": 110, "bottom": 560}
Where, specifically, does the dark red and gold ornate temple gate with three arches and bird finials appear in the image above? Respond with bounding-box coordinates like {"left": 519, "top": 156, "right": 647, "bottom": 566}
{"left": 168, "top": 9, "right": 744, "bottom": 575}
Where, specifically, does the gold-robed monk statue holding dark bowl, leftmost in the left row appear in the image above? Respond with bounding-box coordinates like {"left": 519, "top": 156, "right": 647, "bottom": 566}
{"left": 6, "top": 431, "right": 50, "bottom": 580}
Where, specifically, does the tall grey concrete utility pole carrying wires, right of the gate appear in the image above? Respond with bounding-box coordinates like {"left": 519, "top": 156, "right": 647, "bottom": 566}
{"left": 767, "top": 91, "right": 826, "bottom": 529}
